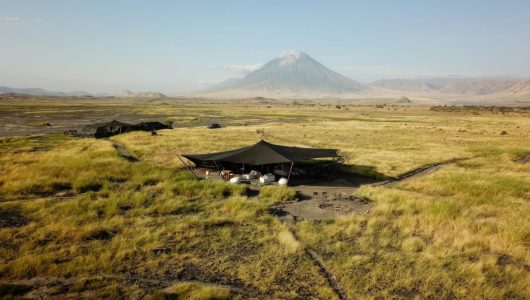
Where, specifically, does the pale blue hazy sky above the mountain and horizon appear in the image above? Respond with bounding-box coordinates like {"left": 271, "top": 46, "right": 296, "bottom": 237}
{"left": 0, "top": 0, "right": 530, "bottom": 94}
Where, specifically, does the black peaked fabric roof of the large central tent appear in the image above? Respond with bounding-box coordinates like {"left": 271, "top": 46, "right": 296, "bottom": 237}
{"left": 182, "top": 140, "right": 339, "bottom": 166}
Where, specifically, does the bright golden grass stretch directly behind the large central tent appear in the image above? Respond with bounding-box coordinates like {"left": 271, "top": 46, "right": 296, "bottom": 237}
{"left": 109, "top": 106, "right": 530, "bottom": 176}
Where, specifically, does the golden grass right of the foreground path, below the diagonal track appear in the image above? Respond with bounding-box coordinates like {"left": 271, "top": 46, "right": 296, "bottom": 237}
{"left": 294, "top": 150, "right": 530, "bottom": 299}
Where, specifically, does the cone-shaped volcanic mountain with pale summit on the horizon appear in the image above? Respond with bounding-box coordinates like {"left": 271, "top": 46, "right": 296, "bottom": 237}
{"left": 208, "top": 52, "right": 370, "bottom": 95}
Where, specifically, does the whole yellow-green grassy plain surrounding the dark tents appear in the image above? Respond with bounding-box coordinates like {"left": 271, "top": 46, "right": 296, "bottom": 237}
{"left": 0, "top": 99, "right": 530, "bottom": 299}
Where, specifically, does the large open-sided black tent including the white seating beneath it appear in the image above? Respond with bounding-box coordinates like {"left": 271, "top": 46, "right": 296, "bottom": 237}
{"left": 179, "top": 140, "right": 344, "bottom": 185}
